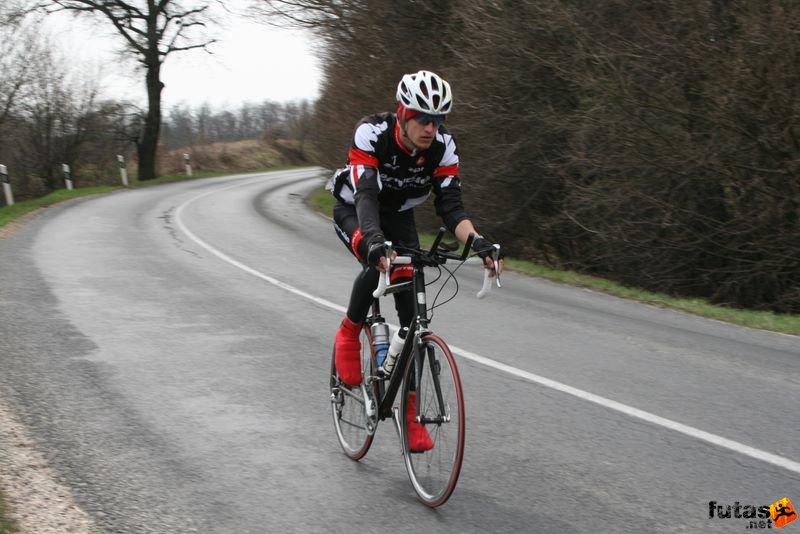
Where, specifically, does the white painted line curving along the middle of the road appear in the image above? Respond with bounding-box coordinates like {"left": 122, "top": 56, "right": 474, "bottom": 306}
{"left": 175, "top": 172, "right": 800, "bottom": 474}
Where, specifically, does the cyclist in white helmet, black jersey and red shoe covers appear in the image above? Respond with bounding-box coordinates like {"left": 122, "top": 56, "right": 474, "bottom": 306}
{"left": 332, "top": 70, "right": 503, "bottom": 451}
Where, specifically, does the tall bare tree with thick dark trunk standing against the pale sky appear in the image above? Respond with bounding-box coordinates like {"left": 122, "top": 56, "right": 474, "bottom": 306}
{"left": 38, "top": 0, "right": 219, "bottom": 180}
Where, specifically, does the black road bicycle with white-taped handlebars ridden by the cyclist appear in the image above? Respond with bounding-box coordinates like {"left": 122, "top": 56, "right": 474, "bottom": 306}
{"left": 330, "top": 229, "right": 500, "bottom": 507}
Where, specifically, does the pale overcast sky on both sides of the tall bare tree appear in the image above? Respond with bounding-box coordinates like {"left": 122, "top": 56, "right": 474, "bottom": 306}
{"left": 39, "top": 2, "right": 320, "bottom": 108}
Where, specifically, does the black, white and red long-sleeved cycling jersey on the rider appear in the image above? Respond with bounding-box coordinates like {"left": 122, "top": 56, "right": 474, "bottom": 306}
{"left": 332, "top": 113, "right": 468, "bottom": 251}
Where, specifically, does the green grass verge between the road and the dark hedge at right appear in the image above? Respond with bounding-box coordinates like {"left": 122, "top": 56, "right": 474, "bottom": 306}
{"left": 309, "top": 185, "right": 800, "bottom": 335}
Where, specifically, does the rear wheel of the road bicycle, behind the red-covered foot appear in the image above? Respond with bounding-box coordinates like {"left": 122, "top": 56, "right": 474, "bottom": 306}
{"left": 330, "top": 328, "right": 378, "bottom": 460}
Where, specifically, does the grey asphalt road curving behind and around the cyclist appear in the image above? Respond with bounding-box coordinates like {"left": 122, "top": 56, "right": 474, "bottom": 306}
{"left": 0, "top": 169, "right": 800, "bottom": 534}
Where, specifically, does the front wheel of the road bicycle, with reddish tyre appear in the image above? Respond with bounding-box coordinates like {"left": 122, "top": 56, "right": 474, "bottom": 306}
{"left": 400, "top": 334, "right": 465, "bottom": 507}
